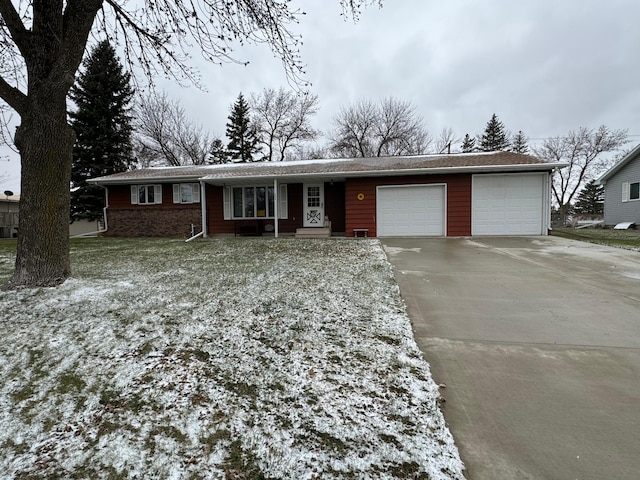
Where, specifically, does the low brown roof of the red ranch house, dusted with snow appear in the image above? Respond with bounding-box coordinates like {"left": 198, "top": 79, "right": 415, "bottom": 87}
{"left": 90, "top": 152, "right": 565, "bottom": 185}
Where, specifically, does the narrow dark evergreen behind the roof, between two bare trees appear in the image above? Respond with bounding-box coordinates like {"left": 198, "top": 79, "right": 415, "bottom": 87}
{"left": 227, "top": 93, "right": 260, "bottom": 162}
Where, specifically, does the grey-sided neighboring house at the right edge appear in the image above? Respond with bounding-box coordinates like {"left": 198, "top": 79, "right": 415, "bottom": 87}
{"left": 596, "top": 145, "right": 640, "bottom": 226}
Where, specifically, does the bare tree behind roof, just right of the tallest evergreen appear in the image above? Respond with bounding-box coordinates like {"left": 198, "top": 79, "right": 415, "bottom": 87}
{"left": 135, "top": 94, "right": 216, "bottom": 166}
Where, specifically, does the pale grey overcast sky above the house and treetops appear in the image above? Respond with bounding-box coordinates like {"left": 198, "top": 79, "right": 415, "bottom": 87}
{"left": 0, "top": 0, "right": 640, "bottom": 193}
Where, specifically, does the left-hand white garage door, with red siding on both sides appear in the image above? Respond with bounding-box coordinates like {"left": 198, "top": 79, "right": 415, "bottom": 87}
{"left": 377, "top": 185, "right": 445, "bottom": 237}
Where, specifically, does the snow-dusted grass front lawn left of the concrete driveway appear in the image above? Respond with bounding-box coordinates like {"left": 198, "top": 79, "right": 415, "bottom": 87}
{"left": 0, "top": 239, "right": 463, "bottom": 480}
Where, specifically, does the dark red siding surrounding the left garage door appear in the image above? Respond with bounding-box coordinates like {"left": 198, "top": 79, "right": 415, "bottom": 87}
{"left": 345, "top": 174, "right": 471, "bottom": 237}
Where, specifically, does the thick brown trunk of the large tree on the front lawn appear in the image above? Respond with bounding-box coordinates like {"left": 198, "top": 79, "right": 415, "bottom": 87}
{"left": 9, "top": 88, "right": 75, "bottom": 287}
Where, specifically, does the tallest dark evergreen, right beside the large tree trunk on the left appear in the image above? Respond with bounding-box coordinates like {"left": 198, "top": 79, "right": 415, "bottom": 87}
{"left": 69, "top": 40, "right": 134, "bottom": 222}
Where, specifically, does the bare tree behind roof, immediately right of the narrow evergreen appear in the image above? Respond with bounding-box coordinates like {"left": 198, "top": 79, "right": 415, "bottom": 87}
{"left": 251, "top": 88, "right": 319, "bottom": 162}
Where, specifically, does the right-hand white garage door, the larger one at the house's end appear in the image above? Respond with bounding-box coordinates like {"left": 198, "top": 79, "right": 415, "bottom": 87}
{"left": 471, "top": 174, "right": 545, "bottom": 235}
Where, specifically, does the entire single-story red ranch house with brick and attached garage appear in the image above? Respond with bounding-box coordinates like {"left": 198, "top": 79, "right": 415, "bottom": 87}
{"left": 90, "top": 152, "right": 563, "bottom": 237}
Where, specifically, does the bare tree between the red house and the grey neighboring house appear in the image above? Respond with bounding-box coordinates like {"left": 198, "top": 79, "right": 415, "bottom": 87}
{"left": 534, "top": 125, "right": 628, "bottom": 214}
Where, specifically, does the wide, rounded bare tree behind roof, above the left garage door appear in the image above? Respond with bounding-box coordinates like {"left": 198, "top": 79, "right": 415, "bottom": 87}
{"left": 330, "top": 97, "right": 431, "bottom": 157}
